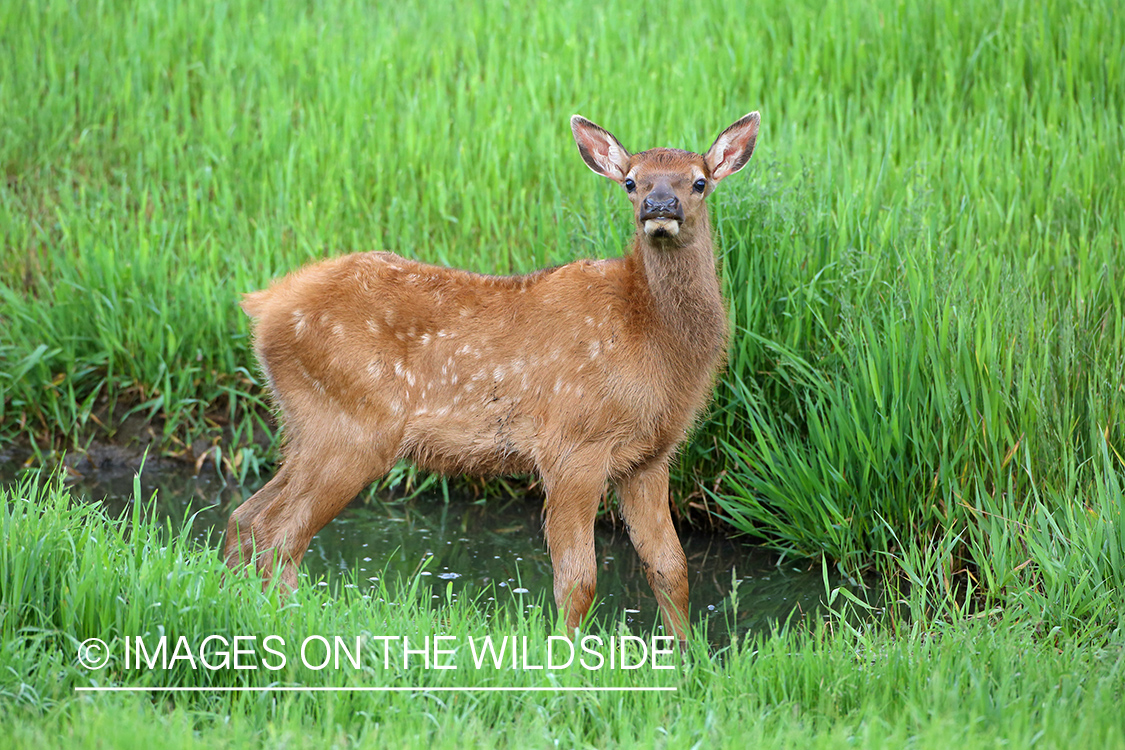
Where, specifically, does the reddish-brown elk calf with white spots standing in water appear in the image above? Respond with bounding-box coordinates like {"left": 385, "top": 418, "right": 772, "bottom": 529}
{"left": 225, "top": 112, "right": 758, "bottom": 640}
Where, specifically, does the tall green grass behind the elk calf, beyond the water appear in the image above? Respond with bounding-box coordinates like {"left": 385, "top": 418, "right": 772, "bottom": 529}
{"left": 0, "top": 0, "right": 1125, "bottom": 591}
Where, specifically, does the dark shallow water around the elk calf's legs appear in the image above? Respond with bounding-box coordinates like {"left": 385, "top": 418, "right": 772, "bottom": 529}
{"left": 0, "top": 463, "right": 839, "bottom": 641}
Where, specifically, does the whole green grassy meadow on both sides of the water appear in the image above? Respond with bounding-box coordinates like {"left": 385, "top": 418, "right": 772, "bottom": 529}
{"left": 0, "top": 0, "right": 1125, "bottom": 747}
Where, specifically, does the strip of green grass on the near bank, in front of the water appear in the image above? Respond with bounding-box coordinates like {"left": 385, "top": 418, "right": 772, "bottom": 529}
{"left": 0, "top": 478, "right": 1125, "bottom": 748}
